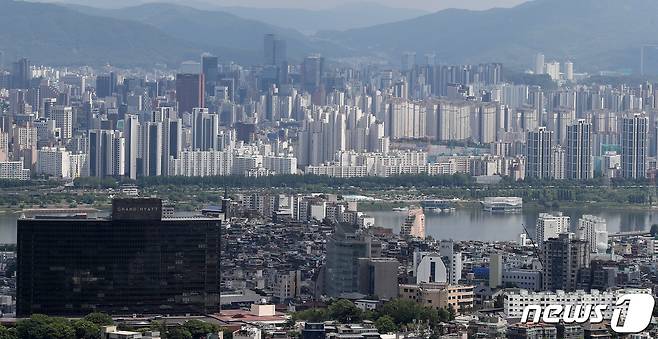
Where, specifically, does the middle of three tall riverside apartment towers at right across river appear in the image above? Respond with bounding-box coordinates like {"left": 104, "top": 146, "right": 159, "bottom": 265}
{"left": 566, "top": 119, "right": 594, "bottom": 180}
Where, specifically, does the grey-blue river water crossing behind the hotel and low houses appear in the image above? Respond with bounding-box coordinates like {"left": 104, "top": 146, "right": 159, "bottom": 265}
{"left": 0, "top": 207, "right": 658, "bottom": 244}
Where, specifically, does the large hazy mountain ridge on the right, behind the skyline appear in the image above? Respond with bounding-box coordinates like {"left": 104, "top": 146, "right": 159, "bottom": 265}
{"left": 320, "top": 0, "right": 658, "bottom": 70}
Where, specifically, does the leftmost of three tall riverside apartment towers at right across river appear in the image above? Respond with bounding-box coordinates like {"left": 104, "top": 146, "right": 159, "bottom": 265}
{"left": 526, "top": 127, "right": 553, "bottom": 179}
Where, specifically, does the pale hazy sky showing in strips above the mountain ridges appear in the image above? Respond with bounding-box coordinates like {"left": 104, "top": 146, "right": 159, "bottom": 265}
{"left": 200, "top": 0, "right": 525, "bottom": 11}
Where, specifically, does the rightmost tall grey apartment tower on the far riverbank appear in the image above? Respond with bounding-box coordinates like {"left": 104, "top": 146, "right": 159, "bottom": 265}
{"left": 621, "top": 113, "right": 649, "bottom": 179}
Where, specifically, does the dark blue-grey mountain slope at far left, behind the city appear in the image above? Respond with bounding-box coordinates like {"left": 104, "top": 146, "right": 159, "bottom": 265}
{"left": 0, "top": 0, "right": 253, "bottom": 66}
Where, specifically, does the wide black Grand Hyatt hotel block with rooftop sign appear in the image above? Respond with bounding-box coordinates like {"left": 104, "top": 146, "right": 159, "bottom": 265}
{"left": 16, "top": 199, "right": 221, "bottom": 317}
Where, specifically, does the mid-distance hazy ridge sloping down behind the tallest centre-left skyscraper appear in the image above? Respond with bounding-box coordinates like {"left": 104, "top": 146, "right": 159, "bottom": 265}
{"left": 71, "top": 3, "right": 336, "bottom": 61}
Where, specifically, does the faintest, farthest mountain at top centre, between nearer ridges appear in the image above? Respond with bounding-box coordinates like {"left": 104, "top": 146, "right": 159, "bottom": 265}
{"left": 221, "top": 2, "right": 427, "bottom": 34}
